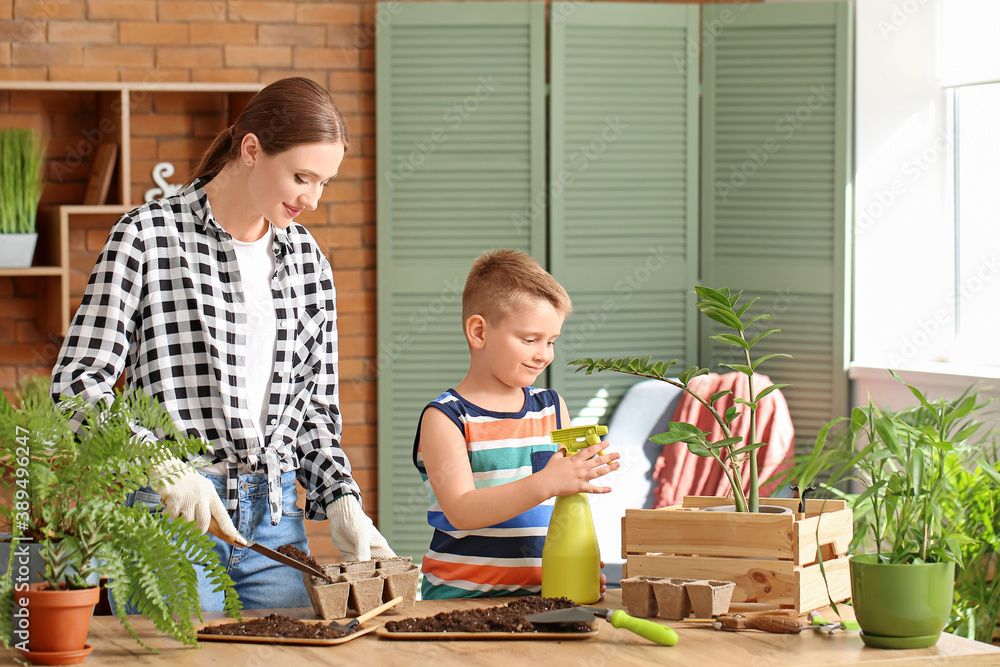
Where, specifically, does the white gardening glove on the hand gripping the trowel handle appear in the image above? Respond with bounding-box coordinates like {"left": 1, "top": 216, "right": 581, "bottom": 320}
{"left": 149, "top": 458, "right": 247, "bottom": 545}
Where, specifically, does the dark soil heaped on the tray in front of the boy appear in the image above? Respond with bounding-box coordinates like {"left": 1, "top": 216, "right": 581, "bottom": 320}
{"left": 385, "top": 595, "right": 592, "bottom": 632}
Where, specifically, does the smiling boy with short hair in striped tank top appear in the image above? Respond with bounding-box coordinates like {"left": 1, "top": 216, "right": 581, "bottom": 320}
{"left": 413, "top": 250, "right": 619, "bottom": 599}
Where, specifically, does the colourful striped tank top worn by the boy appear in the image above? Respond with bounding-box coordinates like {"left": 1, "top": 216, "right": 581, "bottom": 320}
{"left": 413, "top": 387, "right": 561, "bottom": 600}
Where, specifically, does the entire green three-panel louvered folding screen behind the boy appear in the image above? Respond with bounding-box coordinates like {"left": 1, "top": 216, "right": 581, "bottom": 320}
{"left": 371, "top": 2, "right": 851, "bottom": 559}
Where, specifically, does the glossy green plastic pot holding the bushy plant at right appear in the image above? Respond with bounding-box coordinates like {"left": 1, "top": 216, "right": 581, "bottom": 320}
{"left": 851, "top": 554, "right": 955, "bottom": 648}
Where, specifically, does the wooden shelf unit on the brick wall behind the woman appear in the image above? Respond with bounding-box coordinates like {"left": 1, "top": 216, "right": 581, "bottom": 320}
{"left": 0, "top": 81, "right": 263, "bottom": 336}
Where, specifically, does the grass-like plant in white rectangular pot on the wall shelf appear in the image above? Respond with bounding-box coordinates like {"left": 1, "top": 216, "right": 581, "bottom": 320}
{"left": 0, "top": 127, "right": 46, "bottom": 268}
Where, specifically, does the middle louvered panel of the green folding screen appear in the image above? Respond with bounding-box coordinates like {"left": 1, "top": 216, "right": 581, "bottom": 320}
{"left": 548, "top": 3, "right": 698, "bottom": 423}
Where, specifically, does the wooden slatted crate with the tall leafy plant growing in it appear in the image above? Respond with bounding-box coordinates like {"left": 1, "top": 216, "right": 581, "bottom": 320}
{"left": 569, "top": 287, "right": 853, "bottom": 613}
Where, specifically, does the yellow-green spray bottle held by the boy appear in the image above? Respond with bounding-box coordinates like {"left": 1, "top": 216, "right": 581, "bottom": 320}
{"left": 542, "top": 425, "right": 608, "bottom": 604}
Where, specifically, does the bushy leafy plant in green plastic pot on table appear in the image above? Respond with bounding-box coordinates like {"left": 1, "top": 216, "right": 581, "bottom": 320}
{"left": 790, "top": 373, "right": 1000, "bottom": 648}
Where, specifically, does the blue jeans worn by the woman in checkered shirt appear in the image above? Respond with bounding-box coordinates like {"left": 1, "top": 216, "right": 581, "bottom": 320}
{"left": 125, "top": 470, "right": 312, "bottom": 614}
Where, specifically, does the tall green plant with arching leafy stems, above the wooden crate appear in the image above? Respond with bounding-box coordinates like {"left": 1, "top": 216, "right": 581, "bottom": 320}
{"left": 569, "top": 287, "right": 791, "bottom": 512}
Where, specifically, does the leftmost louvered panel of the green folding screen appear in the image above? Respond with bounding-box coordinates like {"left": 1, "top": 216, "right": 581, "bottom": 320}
{"left": 372, "top": 2, "right": 545, "bottom": 559}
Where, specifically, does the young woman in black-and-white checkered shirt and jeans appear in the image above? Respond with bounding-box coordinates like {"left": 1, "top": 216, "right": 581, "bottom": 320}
{"left": 52, "top": 77, "right": 393, "bottom": 610}
